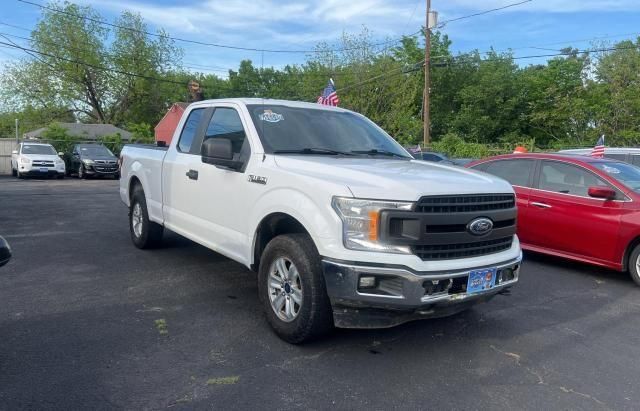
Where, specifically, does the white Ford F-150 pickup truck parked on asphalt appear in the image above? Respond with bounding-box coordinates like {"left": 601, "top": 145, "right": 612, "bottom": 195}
{"left": 120, "top": 99, "right": 522, "bottom": 343}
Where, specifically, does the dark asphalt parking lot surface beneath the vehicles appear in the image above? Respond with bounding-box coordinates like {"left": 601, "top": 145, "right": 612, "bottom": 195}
{"left": 0, "top": 177, "right": 640, "bottom": 409}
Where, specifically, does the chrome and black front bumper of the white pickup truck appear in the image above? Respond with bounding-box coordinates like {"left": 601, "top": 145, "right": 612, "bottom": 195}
{"left": 323, "top": 255, "right": 522, "bottom": 328}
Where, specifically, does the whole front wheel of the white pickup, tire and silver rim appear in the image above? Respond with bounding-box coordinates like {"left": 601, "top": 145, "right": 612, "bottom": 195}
{"left": 258, "top": 234, "right": 333, "bottom": 344}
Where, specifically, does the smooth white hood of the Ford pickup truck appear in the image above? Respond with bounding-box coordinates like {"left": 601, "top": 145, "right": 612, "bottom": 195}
{"left": 275, "top": 155, "right": 513, "bottom": 201}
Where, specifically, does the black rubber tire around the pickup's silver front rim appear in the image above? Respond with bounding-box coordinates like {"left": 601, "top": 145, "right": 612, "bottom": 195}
{"left": 258, "top": 234, "right": 333, "bottom": 344}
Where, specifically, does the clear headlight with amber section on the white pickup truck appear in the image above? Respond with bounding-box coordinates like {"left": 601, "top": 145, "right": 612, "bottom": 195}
{"left": 332, "top": 197, "right": 413, "bottom": 254}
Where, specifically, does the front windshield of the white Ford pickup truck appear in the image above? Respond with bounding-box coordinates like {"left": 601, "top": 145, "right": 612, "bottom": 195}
{"left": 247, "top": 104, "right": 412, "bottom": 159}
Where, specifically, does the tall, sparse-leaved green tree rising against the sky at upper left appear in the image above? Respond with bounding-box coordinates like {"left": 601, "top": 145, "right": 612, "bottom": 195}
{"left": 2, "top": 2, "right": 186, "bottom": 124}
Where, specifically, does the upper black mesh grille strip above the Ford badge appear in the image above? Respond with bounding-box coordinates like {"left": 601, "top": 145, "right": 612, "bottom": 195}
{"left": 415, "top": 194, "right": 515, "bottom": 214}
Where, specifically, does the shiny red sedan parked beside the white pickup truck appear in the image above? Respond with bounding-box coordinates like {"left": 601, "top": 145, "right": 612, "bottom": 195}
{"left": 467, "top": 154, "right": 640, "bottom": 285}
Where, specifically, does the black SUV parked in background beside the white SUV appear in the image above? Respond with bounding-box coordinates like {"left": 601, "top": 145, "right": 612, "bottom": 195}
{"left": 66, "top": 144, "right": 120, "bottom": 178}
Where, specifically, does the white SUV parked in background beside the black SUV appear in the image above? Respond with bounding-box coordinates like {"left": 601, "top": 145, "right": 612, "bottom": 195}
{"left": 11, "top": 142, "right": 65, "bottom": 178}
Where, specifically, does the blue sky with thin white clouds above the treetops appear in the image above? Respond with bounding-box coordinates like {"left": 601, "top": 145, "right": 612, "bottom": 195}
{"left": 0, "top": 0, "right": 640, "bottom": 77}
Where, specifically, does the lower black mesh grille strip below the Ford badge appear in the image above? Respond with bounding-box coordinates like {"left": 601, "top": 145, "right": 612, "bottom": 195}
{"left": 412, "top": 236, "right": 513, "bottom": 261}
